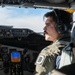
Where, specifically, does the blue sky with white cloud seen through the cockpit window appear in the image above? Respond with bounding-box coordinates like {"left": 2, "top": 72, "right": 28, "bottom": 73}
{"left": 0, "top": 6, "right": 50, "bottom": 32}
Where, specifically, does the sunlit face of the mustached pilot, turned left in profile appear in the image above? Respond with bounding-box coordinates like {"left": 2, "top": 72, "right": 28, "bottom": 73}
{"left": 43, "top": 17, "right": 59, "bottom": 41}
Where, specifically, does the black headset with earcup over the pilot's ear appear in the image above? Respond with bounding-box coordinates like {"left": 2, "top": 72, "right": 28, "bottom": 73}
{"left": 54, "top": 10, "right": 68, "bottom": 34}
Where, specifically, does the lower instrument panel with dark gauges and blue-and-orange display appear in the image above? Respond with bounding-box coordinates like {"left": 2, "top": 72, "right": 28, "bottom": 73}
{"left": 0, "top": 44, "right": 38, "bottom": 75}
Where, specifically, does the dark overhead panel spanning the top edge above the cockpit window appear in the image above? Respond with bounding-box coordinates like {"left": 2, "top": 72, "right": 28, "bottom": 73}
{"left": 0, "top": 0, "right": 75, "bottom": 9}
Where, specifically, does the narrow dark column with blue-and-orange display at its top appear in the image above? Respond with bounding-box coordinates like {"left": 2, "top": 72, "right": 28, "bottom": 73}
{"left": 10, "top": 50, "right": 23, "bottom": 75}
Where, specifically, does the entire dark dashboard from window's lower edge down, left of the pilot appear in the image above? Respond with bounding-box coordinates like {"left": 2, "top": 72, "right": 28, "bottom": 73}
{"left": 0, "top": 26, "right": 50, "bottom": 75}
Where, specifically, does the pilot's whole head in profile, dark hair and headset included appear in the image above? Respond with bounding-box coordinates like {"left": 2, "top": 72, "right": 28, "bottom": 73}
{"left": 43, "top": 9, "right": 72, "bottom": 41}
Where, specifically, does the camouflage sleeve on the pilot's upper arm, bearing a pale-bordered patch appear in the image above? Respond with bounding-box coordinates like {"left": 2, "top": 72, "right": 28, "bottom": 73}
{"left": 34, "top": 50, "right": 55, "bottom": 75}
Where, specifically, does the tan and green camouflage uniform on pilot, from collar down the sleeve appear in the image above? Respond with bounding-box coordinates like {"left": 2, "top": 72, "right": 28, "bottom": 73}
{"left": 34, "top": 34, "right": 70, "bottom": 75}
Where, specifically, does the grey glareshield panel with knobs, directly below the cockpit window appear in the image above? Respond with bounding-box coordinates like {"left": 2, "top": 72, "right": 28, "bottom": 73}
{"left": 0, "top": 26, "right": 34, "bottom": 38}
